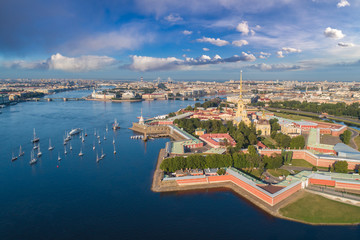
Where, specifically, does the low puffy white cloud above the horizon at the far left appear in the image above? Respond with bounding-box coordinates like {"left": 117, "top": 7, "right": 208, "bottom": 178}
{"left": 4, "top": 53, "right": 116, "bottom": 72}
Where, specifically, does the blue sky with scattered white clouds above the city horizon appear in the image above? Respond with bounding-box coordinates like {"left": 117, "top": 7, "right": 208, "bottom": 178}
{"left": 0, "top": 0, "right": 360, "bottom": 81}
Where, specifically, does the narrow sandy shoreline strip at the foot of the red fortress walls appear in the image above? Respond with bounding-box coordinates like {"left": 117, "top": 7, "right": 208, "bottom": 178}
{"left": 151, "top": 148, "right": 360, "bottom": 226}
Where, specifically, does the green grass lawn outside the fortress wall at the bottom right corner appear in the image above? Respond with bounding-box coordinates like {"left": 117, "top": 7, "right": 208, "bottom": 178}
{"left": 279, "top": 193, "right": 360, "bottom": 223}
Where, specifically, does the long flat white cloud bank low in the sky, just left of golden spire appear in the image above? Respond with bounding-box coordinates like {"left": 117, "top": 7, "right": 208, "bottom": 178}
{"left": 124, "top": 52, "right": 256, "bottom": 71}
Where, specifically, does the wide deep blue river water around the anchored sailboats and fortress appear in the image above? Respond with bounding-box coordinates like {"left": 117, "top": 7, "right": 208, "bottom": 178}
{"left": 0, "top": 90, "right": 360, "bottom": 240}
